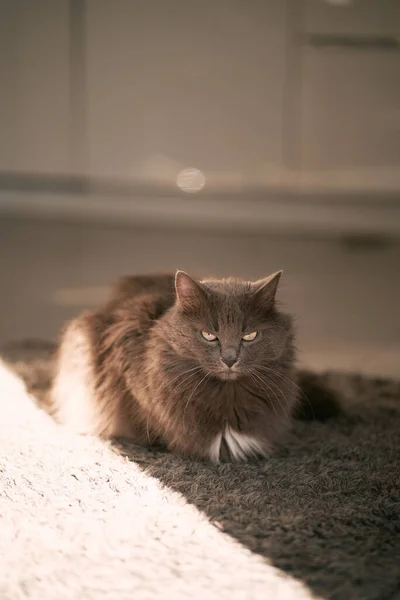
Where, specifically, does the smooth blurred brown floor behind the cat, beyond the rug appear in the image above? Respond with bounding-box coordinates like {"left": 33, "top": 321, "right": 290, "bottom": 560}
{"left": 0, "top": 217, "right": 400, "bottom": 377}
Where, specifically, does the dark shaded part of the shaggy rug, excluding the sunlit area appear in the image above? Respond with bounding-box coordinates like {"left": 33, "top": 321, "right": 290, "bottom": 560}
{"left": 2, "top": 342, "right": 400, "bottom": 600}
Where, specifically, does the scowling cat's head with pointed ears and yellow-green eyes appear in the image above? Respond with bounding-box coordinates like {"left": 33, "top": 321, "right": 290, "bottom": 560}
{"left": 166, "top": 271, "right": 293, "bottom": 380}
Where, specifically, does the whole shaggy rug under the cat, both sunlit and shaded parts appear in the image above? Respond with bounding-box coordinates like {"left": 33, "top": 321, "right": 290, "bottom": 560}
{"left": 0, "top": 343, "right": 400, "bottom": 600}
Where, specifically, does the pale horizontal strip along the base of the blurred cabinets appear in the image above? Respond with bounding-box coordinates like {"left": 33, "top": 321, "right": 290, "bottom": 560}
{"left": 0, "top": 191, "right": 400, "bottom": 243}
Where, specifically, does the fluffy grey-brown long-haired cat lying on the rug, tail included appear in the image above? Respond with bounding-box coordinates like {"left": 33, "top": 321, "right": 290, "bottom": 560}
{"left": 51, "top": 271, "right": 339, "bottom": 463}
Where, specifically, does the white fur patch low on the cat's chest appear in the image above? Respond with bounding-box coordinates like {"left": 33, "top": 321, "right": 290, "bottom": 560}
{"left": 209, "top": 424, "right": 266, "bottom": 463}
